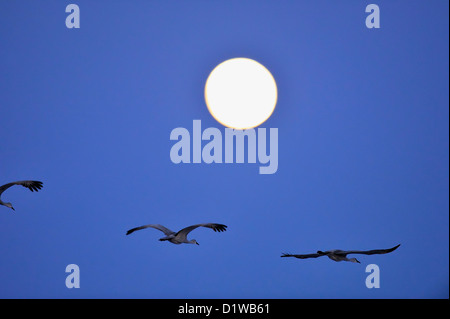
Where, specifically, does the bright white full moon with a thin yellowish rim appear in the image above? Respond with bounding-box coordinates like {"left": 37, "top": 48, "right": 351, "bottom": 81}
{"left": 205, "top": 58, "right": 278, "bottom": 130}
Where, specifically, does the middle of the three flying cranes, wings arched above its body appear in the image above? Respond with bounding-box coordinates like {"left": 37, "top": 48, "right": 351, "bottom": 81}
{"left": 127, "top": 223, "right": 228, "bottom": 245}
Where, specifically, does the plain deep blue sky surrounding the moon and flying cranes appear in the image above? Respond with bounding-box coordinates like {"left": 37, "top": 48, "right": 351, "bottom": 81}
{"left": 0, "top": 0, "right": 449, "bottom": 298}
